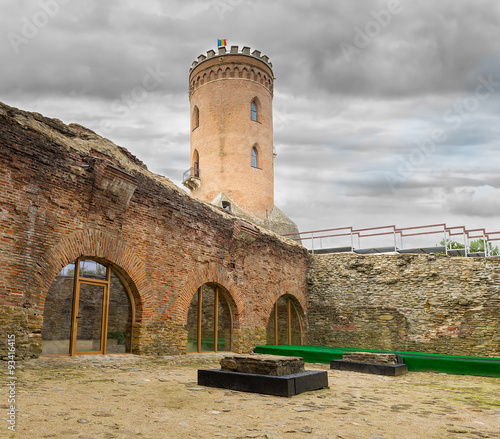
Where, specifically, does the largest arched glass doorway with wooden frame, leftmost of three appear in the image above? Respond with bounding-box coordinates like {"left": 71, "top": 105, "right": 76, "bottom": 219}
{"left": 42, "top": 258, "right": 135, "bottom": 355}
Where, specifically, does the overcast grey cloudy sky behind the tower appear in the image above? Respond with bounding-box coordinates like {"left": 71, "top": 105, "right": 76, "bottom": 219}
{"left": 0, "top": 0, "right": 500, "bottom": 248}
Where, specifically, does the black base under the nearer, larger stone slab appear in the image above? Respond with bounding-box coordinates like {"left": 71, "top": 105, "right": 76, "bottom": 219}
{"left": 198, "top": 369, "right": 328, "bottom": 396}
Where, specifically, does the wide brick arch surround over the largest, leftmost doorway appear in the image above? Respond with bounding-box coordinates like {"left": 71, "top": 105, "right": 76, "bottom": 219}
{"left": 28, "top": 229, "right": 151, "bottom": 319}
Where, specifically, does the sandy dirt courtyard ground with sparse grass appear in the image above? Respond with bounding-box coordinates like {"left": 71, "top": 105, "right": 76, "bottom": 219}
{"left": 0, "top": 354, "right": 500, "bottom": 439}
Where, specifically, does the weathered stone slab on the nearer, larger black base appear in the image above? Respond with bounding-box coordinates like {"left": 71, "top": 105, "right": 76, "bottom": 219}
{"left": 220, "top": 354, "right": 304, "bottom": 376}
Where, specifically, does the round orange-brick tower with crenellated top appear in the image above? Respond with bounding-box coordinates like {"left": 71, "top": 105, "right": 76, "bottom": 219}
{"left": 183, "top": 46, "right": 297, "bottom": 234}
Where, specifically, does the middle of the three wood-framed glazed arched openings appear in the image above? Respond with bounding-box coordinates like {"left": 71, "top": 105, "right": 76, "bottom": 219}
{"left": 186, "top": 283, "right": 233, "bottom": 352}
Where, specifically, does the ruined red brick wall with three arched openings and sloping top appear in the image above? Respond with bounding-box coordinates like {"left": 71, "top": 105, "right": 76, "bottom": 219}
{"left": 0, "top": 104, "right": 309, "bottom": 357}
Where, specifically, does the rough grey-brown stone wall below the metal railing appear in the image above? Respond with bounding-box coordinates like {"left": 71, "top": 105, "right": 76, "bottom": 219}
{"left": 306, "top": 254, "right": 500, "bottom": 357}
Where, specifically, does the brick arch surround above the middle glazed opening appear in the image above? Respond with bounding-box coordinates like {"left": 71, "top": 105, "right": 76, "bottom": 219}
{"left": 178, "top": 263, "right": 245, "bottom": 327}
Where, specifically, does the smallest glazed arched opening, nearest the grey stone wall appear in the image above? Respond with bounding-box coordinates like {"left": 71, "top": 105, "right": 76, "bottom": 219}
{"left": 266, "top": 294, "right": 302, "bottom": 345}
